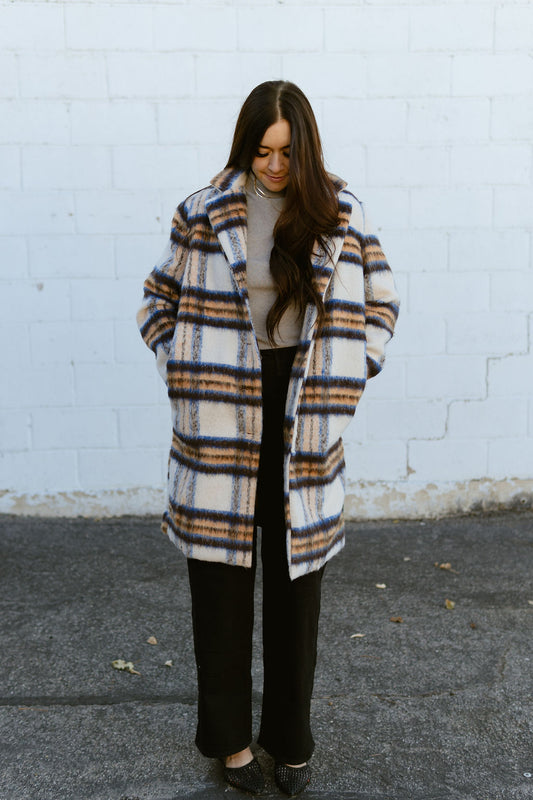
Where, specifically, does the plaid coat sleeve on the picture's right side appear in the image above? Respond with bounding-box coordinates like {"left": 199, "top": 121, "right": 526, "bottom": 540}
{"left": 361, "top": 206, "right": 400, "bottom": 378}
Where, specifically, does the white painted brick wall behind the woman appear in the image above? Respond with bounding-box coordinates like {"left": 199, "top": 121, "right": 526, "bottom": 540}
{"left": 0, "top": 0, "right": 533, "bottom": 516}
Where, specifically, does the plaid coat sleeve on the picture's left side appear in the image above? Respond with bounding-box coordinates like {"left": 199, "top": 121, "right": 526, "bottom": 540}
{"left": 137, "top": 203, "right": 188, "bottom": 381}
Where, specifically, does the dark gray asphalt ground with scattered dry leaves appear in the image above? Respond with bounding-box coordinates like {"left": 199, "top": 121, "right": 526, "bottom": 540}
{"left": 0, "top": 513, "right": 533, "bottom": 800}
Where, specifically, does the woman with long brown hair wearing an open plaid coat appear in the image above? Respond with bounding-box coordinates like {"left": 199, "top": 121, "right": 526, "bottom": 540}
{"left": 138, "top": 81, "right": 398, "bottom": 796}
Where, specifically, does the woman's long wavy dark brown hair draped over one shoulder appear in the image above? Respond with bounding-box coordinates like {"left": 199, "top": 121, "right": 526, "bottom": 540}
{"left": 226, "top": 81, "right": 339, "bottom": 344}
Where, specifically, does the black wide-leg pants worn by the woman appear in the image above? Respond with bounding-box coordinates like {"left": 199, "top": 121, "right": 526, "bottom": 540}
{"left": 188, "top": 348, "right": 324, "bottom": 764}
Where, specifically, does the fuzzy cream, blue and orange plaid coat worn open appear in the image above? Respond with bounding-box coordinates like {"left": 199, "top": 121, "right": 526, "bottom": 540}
{"left": 137, "top": 169, "right": 398, "bottom": 579}
